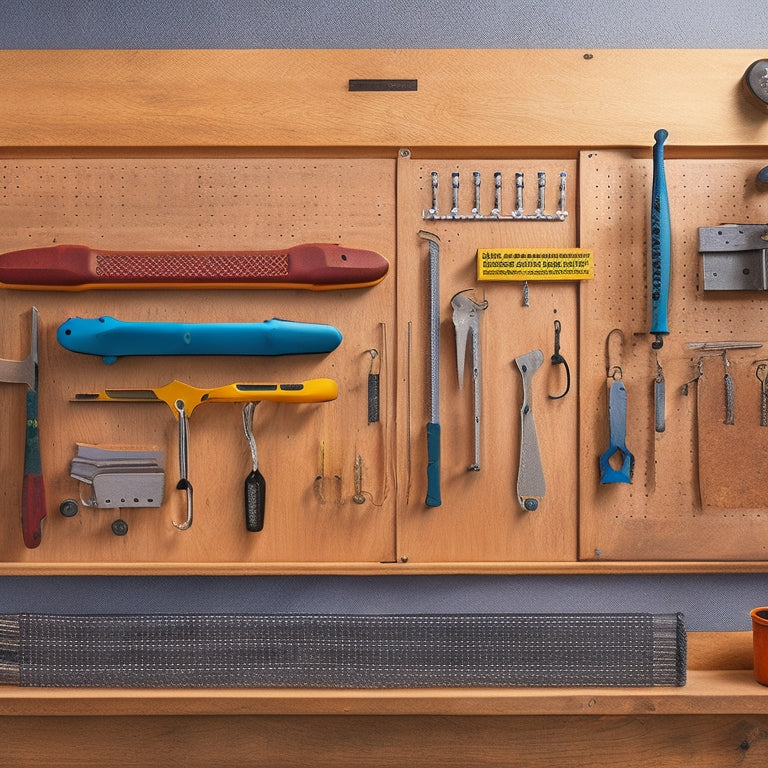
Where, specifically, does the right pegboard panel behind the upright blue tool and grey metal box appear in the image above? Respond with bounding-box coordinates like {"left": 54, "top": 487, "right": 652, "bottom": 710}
{"left": 579, "top": 151, "right": 768, "bottom": 560}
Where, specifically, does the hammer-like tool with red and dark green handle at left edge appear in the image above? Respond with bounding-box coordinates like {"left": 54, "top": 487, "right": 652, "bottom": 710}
{"left": 0, "top": 307, "right": 47, "bottom": 549}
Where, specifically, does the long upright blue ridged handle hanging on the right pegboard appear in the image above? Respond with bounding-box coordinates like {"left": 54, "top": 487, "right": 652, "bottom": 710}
{"left": 651, "top": 128, "right": 671, "bottom": 333}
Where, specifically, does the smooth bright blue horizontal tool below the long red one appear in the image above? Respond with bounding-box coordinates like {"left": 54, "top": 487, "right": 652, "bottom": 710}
{"left": 56, "top": 316, "right": 341, "bottom": 363}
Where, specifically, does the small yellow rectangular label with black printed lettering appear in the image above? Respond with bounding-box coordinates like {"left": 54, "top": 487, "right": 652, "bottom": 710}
{"left": 477, "top": 248, "right": 594, "bottom": 280}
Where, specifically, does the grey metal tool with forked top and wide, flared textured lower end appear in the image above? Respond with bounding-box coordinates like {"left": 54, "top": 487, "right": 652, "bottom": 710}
{"left": 515, "top": 349, "right": 547, "bottom": 512}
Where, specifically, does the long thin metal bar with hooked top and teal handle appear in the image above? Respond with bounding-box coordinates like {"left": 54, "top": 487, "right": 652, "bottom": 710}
{"left": 419, "top": 229, "right": 442, "bottom": 507}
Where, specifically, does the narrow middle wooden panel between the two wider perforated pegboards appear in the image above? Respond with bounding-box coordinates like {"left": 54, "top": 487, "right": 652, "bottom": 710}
{"left": 397, "top": 155, "right": 578, "bottom": 564}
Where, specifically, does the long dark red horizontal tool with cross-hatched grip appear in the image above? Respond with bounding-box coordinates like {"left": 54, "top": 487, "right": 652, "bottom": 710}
{"left": 0, "top": 243, "right": 389, "bottom": 291}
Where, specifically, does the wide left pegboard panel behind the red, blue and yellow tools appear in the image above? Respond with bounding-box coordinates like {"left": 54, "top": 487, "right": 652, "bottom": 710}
{"left": 0, "top": 158, "right": 396, "bottom": 571}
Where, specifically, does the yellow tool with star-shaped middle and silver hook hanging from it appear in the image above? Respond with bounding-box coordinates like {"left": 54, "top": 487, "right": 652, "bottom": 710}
{"left": 74, "top": 379, "right": 338, "bottom": 531}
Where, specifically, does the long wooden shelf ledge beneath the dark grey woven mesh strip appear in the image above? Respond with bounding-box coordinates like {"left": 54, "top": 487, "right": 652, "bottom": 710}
{"left": 0, "top": 670, "right": 768, "bottom": 716}
